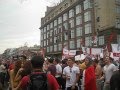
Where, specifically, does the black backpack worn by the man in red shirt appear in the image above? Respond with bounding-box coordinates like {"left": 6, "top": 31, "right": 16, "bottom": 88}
{"left": 26, "top": 73, "right": 48, "bottom": 90}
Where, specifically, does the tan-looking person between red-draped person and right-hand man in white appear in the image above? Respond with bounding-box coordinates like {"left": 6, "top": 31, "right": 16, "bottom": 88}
{"left": 93, "top": 59, "right": 102, "bottom": 90}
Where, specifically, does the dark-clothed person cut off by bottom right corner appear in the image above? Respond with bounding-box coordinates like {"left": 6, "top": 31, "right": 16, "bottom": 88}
{"left": 110, "top": 65, "right": 120, "bottom": 90}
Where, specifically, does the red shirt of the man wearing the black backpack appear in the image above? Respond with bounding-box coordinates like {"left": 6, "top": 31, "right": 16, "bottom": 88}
{"left": 21, "top": 74, "right": 59, "bottom": 90}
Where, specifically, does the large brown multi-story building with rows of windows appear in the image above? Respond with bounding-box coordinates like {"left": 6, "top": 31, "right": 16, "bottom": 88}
{"left": 40, "top": 0, "right": 120, "bottom": 55}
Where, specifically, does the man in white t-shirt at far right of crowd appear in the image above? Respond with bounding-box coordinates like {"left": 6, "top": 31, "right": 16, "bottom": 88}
{"left": 101, "top": 56, "right": 116, "bottom": 90}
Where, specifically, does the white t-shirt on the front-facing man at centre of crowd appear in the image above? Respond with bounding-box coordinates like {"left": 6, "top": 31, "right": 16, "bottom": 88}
{"left": 63, "top": 66, "right": 80, "bottom": 87}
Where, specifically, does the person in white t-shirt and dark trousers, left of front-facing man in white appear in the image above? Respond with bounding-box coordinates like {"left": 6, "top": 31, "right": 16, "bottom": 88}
{"left": 53, "top": 58, "right": 62, "bottom": 88}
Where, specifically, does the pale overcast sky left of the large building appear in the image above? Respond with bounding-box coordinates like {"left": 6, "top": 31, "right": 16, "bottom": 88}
{"left": 0, "top": 0, "right": 59, "bottom": 54}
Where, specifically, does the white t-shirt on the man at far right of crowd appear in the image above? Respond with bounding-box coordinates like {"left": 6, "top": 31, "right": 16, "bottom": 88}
{"left": 103, "top": 63, "right": 116, "bottom": 82}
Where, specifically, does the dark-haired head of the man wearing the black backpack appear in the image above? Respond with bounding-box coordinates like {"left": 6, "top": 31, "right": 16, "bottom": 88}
{"left": 31, "top": 55, "right": 44, "bottom": 69}
